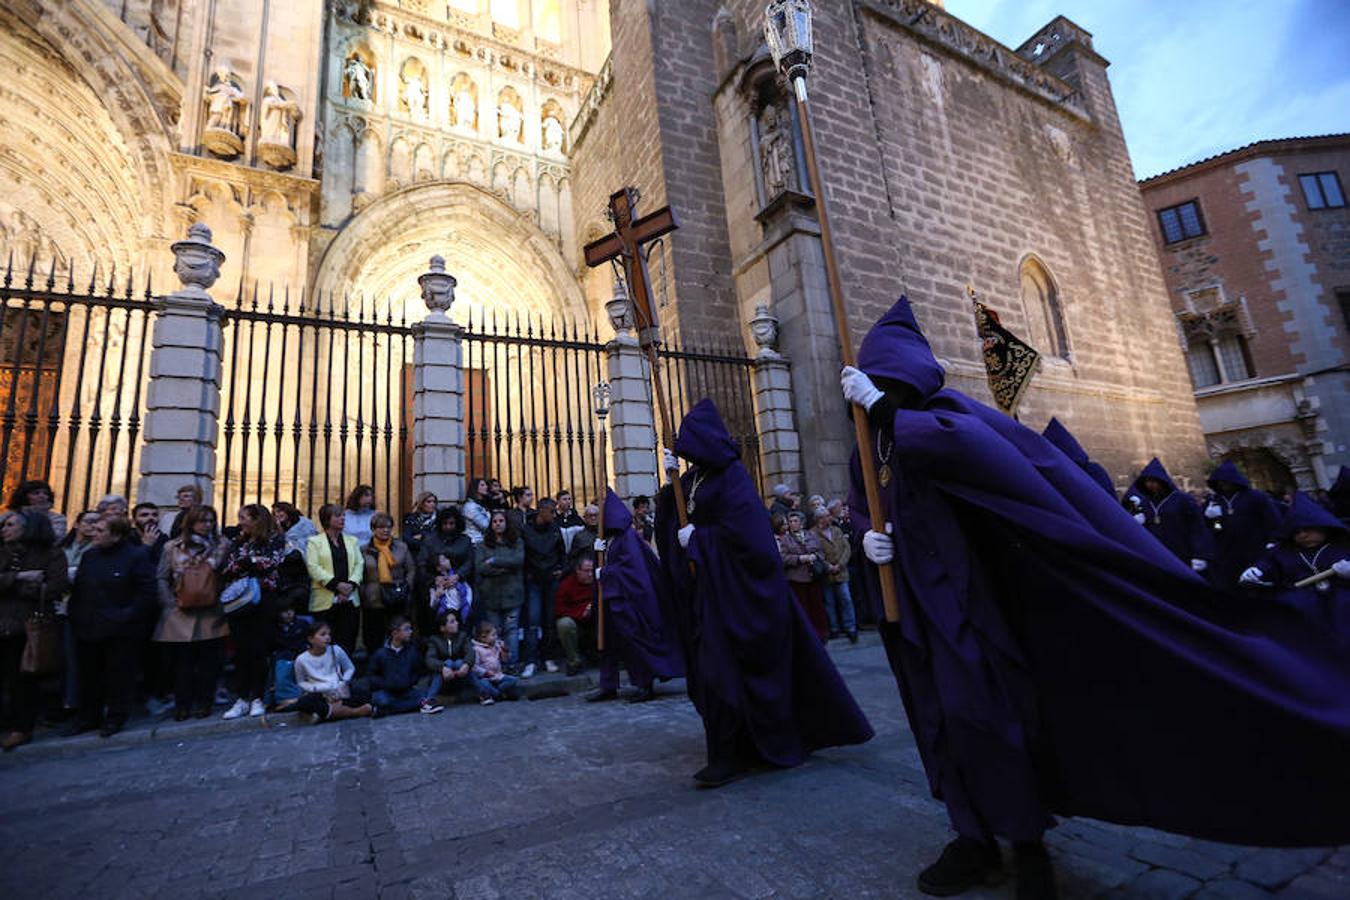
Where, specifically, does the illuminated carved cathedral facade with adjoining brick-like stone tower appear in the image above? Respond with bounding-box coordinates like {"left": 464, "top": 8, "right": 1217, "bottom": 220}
{"left": 0, "top": 0, "right": 1204, "bottom": 507}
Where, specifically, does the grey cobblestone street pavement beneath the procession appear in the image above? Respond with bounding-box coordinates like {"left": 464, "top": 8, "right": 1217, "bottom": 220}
{"left": 0, "top": 636, "right": 1350, "bottom": 900}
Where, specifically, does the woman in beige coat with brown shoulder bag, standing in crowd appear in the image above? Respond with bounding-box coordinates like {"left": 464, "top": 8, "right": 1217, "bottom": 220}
{"left": 153, "top": 506, "right": 230, "bottom": 722}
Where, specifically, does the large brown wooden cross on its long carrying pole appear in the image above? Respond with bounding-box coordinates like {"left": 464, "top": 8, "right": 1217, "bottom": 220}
{"left": 586, "top": 188, "right": 689, "bottom": 528}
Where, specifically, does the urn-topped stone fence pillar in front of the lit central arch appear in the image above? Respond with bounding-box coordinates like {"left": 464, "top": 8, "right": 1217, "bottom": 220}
{"left": 409, "top": 256, "right": 464, "bottom": 503}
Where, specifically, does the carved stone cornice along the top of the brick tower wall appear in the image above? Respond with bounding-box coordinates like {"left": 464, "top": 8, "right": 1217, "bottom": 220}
{"left": 857, "top": 0, "right": 1092, "bottom": 121}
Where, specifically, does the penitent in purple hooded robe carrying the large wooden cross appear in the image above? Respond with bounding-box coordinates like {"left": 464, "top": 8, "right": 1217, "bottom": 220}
{"left": 656, "top": 399, "right": 872, "bottom": 766}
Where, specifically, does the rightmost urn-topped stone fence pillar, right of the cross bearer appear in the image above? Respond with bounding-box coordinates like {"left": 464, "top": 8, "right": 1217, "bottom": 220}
{"left": 751, "top": 304, "right": 805, "bottom": 494}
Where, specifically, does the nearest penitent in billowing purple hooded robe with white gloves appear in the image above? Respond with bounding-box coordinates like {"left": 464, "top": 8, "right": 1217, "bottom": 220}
{"left": 851, "top": 298, "right": 1350, "bottom": 846}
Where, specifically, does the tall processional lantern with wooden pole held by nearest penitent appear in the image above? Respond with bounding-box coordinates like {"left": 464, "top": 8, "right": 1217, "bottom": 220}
{"left": 764, "top": 0, "right": 900, "bottom": 622}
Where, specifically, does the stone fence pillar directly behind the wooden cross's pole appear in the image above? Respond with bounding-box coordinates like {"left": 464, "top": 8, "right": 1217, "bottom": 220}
{"left": 605, "top": 329, "right": 660, "bottom": 499}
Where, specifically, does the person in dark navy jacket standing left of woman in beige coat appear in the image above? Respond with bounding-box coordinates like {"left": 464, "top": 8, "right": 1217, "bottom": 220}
{"left": 69, "top": 518, "right": 158, "bottom": 738}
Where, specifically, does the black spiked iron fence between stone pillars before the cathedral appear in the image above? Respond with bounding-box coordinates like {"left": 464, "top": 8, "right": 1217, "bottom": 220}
{"left": 0, "top": 253, "right": 760, "bottom": 521}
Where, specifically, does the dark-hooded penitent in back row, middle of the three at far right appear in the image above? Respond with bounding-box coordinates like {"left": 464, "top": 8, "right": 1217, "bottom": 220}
{"left": 1204, "top": 461, "right": 1280, "bottom": 591}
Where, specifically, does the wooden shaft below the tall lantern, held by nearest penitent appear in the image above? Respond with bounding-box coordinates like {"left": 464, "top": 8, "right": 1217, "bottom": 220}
{"left": 792, "top": 77, "right": 900, "bottom": 622}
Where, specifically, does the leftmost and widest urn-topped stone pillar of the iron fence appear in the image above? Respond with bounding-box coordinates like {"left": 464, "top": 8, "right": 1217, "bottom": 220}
{"left": 135, "top": 223, "right": 225, "bottom": 510}
